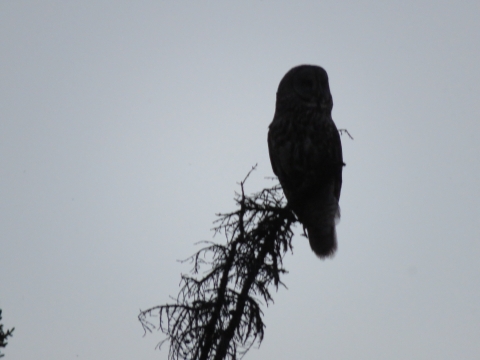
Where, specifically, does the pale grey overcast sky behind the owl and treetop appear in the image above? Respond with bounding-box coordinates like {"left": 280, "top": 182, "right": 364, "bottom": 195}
{"left": 0, "top": 0, "right": 480, "bottom": 360}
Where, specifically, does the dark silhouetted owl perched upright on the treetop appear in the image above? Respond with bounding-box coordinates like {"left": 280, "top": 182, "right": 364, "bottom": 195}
{"left": 268, "top": 65, "right": 345, "bottom": 258}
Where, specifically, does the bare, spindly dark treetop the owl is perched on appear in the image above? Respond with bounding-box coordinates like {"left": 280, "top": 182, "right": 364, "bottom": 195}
{"left": 138, "top": 168, "right": 297, "bottom": 360}
